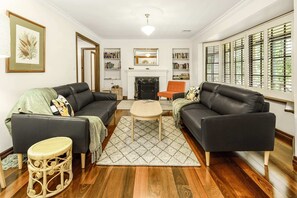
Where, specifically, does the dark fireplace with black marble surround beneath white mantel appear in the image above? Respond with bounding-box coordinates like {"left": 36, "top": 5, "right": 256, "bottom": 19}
{"left": 134, "top": 77, "right": 159, "bottom": 100}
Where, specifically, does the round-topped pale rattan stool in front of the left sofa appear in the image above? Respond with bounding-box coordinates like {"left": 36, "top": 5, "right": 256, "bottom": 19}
{"left": 27, "top": 137, "right": 73, "bottom": 197}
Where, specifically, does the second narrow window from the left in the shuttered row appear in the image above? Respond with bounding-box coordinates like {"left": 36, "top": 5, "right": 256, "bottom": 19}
{"left": 223, "top": 43, "right": 231, "bottom": 83}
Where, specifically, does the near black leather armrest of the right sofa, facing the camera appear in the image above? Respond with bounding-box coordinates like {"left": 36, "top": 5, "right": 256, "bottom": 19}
{"left": 201, "top": 112, "right": 275, "bottom": 152}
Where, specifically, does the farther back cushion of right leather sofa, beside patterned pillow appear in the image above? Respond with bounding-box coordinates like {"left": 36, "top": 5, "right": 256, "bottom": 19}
{"left": 200, "top": 82, "right": 220, "bottom": 109}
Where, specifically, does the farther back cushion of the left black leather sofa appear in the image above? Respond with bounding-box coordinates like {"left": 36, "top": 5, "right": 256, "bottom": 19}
{"left": 68, "top": 83, "right": 94, "bottom": 111}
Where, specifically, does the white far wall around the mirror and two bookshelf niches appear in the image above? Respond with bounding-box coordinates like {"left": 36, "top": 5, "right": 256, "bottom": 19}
{"left": 101, "top": 39, "right": 195, "bottom": 96}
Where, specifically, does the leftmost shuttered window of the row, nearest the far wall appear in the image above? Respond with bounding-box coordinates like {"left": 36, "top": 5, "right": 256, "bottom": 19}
{"left": 206, "top": 45, "right": 219, "bottom": 82}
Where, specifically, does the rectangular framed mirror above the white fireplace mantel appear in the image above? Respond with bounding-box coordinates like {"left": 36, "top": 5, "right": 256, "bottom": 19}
{"left": 134, "top": 48, "right": 159, "bottom": 66}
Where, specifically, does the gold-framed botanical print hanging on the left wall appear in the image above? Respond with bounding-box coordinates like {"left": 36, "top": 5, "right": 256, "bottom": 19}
{"left": 6, "top": 11, "right": 46, "bottom": 73}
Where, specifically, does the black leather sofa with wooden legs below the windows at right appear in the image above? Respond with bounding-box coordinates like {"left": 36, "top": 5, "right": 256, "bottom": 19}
{"left": 180, "top": 82, "right": 275, "bottom": 166}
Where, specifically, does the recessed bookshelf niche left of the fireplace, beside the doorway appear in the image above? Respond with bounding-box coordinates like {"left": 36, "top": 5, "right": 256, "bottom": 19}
{"left": 103, "top": 48, "right": 121, "bottom": 80}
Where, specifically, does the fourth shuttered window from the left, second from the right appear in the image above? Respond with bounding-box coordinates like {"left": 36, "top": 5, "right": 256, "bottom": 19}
{"left": 249, "top": 32, "right": 264, "bottom": 88}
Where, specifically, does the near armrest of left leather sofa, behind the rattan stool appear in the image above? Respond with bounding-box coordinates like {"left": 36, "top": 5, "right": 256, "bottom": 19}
{"left": 11, "top": 114, "right": 90, "bottom": 153}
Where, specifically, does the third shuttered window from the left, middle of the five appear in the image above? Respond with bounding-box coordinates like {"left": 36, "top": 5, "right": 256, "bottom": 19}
{"left": 233, "top": 38, "right": 244, "bottom": 85}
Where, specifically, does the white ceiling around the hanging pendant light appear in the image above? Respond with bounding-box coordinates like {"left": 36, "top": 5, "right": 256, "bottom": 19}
{"left": 47, "top": 0, "right": 240, "bottom": 39}
